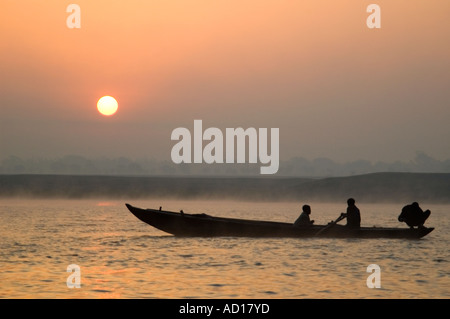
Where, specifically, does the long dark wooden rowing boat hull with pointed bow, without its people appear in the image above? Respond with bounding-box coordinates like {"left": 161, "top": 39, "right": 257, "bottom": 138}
{"left": 126, "top": 204, "right": 434, "bottom": 239}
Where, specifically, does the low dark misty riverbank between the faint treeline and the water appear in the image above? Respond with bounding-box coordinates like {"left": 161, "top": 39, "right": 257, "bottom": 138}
{"left": 0, "top": 173, "right": 450, "bottom": 203}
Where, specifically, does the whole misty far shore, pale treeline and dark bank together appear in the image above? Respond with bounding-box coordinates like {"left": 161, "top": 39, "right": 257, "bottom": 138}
{"left": 0, "top": 152, "right": 450, "bottom": 203}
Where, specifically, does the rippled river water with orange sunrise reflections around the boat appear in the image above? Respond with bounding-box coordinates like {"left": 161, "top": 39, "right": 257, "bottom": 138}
{"left": 0, "top": 199, "right": 450, "bottom": 299}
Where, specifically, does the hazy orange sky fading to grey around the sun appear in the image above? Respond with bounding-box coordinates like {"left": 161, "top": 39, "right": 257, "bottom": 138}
{"left": 0, "top": 0, "right": 450, "bottom": 168}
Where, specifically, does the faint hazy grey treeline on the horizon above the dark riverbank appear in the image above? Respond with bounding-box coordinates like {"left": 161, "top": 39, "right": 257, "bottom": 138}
{"left": 0, "top": 152, "right": 450, "bottom": 177}
